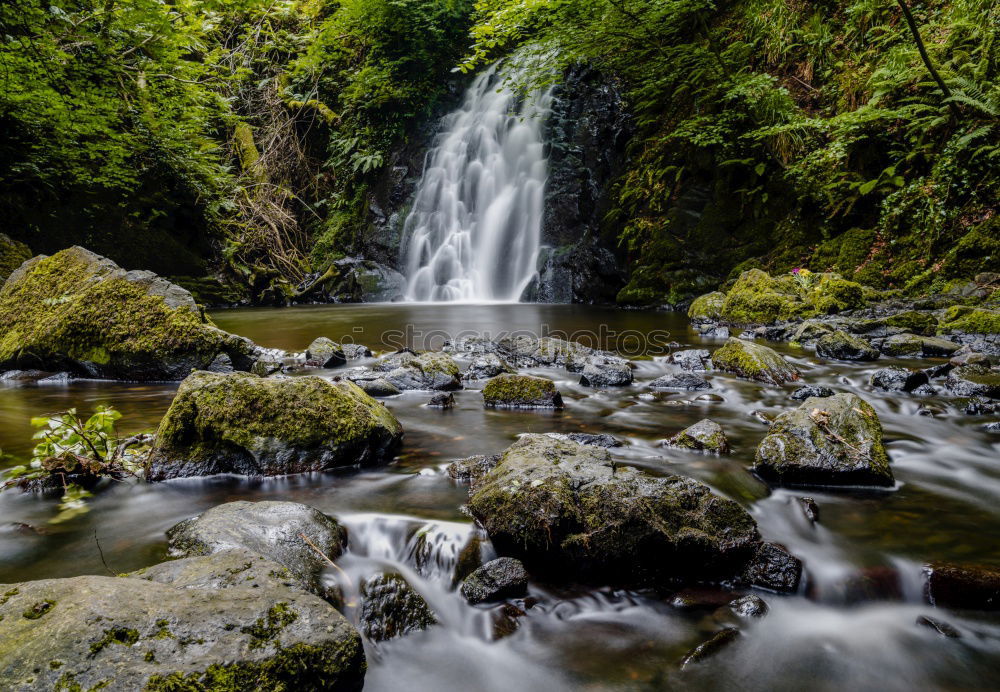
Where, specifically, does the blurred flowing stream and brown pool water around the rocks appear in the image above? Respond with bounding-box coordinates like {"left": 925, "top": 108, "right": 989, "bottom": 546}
{"left": 0, "top": 303, "right": 1000, "bottom": 692}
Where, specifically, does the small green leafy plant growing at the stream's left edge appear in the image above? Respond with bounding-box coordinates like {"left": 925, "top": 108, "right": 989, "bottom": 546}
{"left": 0, "top": 406, "right": 149, "bottom": 523}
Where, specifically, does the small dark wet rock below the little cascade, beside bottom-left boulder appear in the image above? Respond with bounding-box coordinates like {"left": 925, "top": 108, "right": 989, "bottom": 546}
{"left": 359, "top": 574, "right": 437, "bottom": 642}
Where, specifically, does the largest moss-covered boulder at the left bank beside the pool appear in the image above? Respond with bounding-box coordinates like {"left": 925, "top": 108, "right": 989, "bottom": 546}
{"left": 0, "top": 247, "right": 257, "bottom": 380}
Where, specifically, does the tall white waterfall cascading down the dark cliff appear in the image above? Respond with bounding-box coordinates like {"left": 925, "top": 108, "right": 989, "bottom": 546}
{"left": 403, "top": 65, "right": 552, "bottom": 302}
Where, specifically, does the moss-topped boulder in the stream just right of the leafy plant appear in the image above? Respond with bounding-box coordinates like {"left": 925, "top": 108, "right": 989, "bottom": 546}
{"left": 148, "top": 372, "right": 403, "bottom": 480}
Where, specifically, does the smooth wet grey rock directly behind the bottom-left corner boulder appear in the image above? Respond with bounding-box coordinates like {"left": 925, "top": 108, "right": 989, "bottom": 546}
{"left": 167, "top": 501, "right": 347, "bottom": 596}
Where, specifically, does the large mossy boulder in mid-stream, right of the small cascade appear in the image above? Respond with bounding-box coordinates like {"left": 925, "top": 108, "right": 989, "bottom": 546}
{"left": 468, "top": 434, "right": 759, "bottom": 583}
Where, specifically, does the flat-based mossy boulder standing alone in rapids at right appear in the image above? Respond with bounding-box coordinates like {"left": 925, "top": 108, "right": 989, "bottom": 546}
{"left": 753, "top": 394, "right": 894, "bottom": 486}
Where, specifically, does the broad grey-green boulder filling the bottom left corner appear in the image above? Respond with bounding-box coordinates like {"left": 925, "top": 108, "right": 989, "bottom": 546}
{"left": 0, "top": 576, "right": 366, "bottom": 691}
